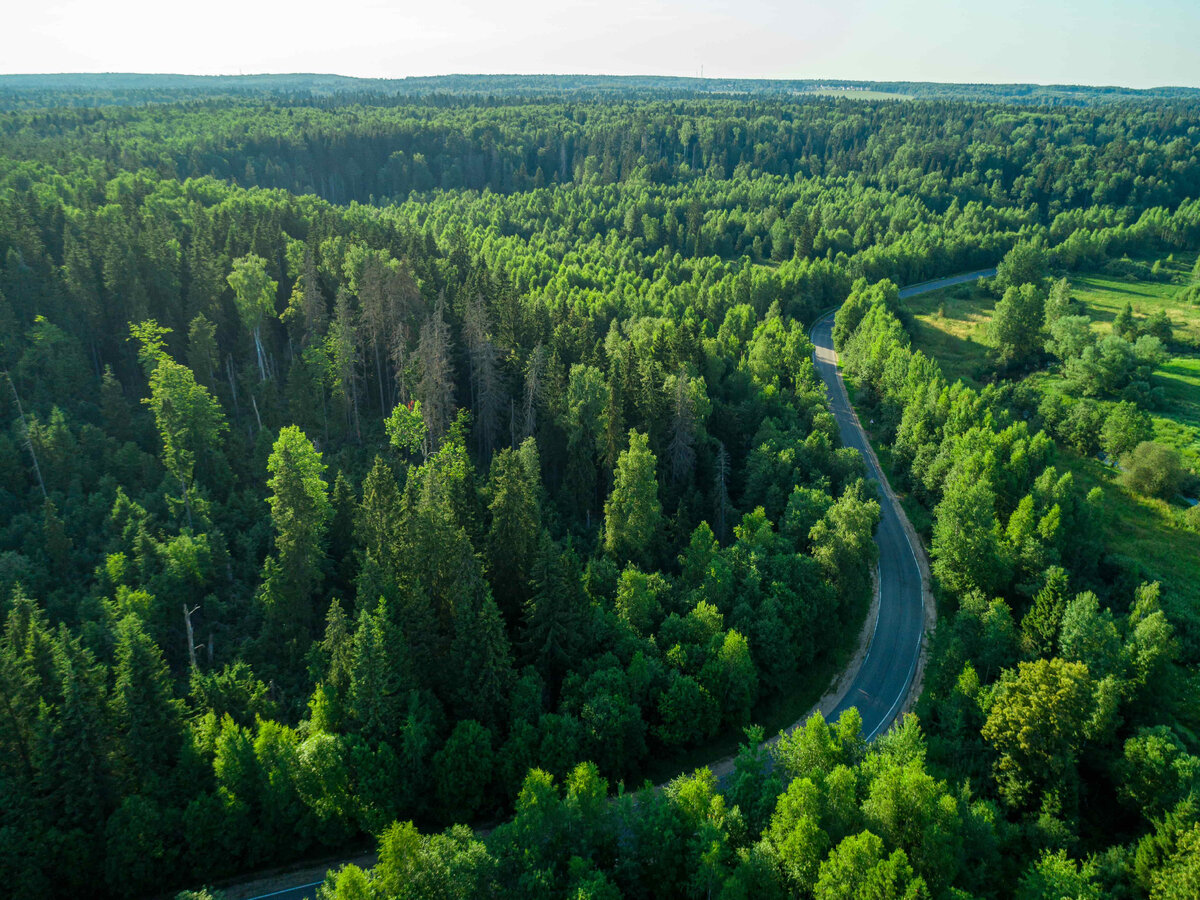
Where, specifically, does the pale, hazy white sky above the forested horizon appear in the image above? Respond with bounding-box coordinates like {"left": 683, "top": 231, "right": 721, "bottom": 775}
{"left": 9, "top": 0, "right": 1200, "bottom": 88}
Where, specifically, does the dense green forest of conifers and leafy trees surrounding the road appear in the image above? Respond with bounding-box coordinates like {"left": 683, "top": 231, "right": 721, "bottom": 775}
{"left": 0, "top": 82, "right": 1200, "bottom": 900}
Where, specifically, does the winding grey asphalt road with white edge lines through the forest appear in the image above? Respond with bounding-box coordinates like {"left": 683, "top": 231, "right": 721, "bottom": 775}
{"left": 230, "top": 269, "right": 996, "bottom": 900}
